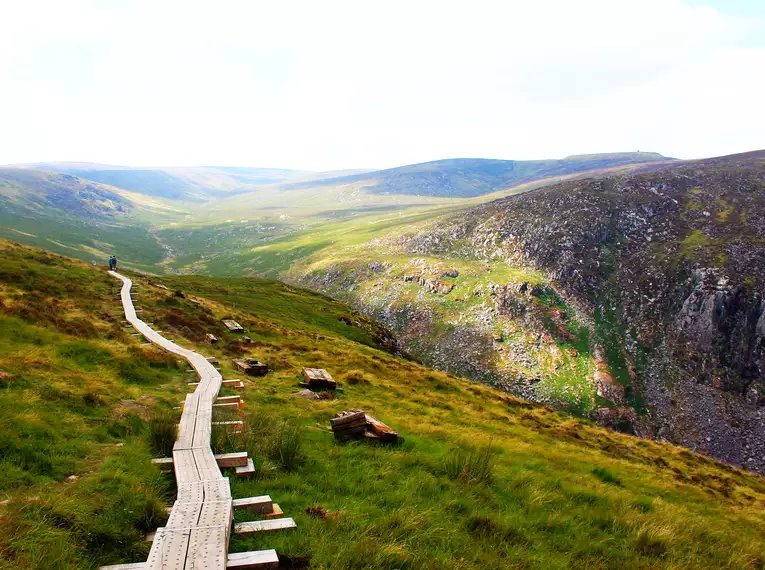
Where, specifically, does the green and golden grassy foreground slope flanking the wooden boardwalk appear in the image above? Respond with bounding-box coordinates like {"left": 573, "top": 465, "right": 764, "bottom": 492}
{"left": 0, "top": 237, "right": 765, "bottom": 569}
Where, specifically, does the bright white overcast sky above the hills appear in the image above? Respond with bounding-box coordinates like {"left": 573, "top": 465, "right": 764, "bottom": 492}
{"left": 0, "top": 0, "right": 765, "bottom": 170}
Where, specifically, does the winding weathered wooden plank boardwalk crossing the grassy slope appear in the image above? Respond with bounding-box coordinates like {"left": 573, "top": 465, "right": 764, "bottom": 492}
{"left": 104, "top": 271, "right": 294, "bottom": 570}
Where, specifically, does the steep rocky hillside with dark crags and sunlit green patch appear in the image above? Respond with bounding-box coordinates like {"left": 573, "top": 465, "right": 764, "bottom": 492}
{"left": 286, "top": 152, "right": 765, "bottom": 472}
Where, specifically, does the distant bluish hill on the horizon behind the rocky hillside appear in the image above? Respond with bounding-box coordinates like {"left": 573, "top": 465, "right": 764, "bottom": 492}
{"left": 283, "top": 152, "right": 673, "bottom": 198}
